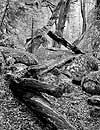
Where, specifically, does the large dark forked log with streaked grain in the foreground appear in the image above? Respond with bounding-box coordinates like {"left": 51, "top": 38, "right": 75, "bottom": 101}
{"left": 9, "top": 75, "right": 75, "bottom": 130}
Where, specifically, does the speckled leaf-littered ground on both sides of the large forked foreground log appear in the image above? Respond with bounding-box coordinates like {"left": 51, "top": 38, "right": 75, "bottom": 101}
{"left": 0, "top": 47, "right": 100, "bottom": 130}
